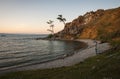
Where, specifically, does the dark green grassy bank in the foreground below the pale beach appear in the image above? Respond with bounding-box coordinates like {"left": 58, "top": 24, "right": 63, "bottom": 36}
{"left": 0, "top": 40, "right": 120, "bottom": 79}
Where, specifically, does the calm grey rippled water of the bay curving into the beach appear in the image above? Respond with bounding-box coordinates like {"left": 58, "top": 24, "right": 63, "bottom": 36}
{"left": 0, "top": 35, "right": 82, "bottom": 70}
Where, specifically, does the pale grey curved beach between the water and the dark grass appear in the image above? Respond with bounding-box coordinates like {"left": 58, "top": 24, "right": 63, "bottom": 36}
{"left": 1, "top": 39, "right": 110, "bottom": 73}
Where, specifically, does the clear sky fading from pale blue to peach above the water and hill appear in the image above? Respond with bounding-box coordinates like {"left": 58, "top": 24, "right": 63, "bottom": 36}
{"left": 0, "top": 0, "right": 120, "bottom": 34}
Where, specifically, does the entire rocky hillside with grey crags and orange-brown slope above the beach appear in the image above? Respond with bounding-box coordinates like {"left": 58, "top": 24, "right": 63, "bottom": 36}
{"left": 55, "top": 7, "right": 120, "bottom": 39}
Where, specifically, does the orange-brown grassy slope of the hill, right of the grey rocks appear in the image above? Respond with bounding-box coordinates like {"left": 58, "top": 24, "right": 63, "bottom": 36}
{"left": 79, "top": 7, "right": 120, "bottom": 41}
